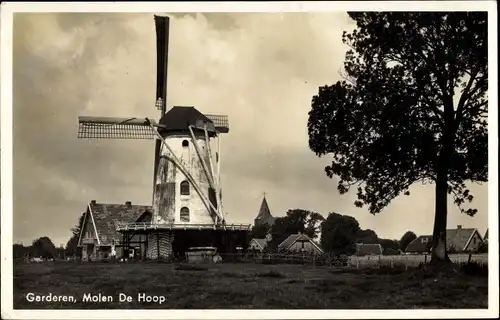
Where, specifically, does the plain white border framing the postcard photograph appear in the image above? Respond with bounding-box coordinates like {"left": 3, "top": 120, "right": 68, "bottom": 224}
{"left": 0, "top": 1, "right": 499, "bottom": 319}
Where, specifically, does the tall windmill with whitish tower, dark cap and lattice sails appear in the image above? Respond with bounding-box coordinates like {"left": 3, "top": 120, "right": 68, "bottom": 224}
{"left": 78, "top": 15, "right": 250, "bottom": 258}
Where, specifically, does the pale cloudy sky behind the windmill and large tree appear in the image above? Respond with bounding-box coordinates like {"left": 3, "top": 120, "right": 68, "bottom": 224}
{"left": 13, "top": 13, "right": 487, "bottom": 245}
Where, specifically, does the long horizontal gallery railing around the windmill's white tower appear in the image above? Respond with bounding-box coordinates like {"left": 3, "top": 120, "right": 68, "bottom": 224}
{"left": 116, "top": 222, "right": 251, "bottom": 231}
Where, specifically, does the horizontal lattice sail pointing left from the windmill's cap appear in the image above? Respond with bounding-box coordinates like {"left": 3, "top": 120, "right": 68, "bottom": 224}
{"left": 78, "top": 117, "right": 156, "bottom": 140}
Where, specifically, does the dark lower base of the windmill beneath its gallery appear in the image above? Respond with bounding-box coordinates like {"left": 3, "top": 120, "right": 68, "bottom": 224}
{"left": 120, "top": 224, "right": 248, "bottom": 260}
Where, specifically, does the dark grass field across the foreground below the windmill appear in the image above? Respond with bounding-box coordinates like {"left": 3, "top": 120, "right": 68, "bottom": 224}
{"left": 14, "top": 263, "right": 488, "bottom": 309}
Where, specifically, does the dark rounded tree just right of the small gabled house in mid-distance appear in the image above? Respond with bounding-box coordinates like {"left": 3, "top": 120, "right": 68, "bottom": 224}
{"left": 320, "top": 212, "right": 359, "bottom": 254}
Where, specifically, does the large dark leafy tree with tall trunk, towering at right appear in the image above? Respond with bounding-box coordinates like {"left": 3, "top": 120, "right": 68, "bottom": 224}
{"left": 308, "top": 12, "right": 488, "bottom": 263}
